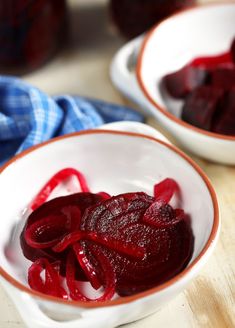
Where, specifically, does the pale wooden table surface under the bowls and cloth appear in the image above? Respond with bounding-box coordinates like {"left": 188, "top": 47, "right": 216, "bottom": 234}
{"left": 0, "top": 0, "right": 235, "bottom": 328}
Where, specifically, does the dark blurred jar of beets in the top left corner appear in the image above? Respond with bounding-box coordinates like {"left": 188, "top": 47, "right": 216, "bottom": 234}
{"left": 0, "top": 0, "right": 66, "bottom": 74}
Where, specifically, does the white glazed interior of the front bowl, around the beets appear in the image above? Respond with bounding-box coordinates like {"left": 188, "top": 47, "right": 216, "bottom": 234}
{"left": 0, "top": 131, "right": 214, "bottom": 294}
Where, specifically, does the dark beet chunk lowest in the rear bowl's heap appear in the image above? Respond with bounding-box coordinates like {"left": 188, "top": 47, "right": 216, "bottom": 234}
{"left": 182, "top": 86, "right": 224, "bottom": 130}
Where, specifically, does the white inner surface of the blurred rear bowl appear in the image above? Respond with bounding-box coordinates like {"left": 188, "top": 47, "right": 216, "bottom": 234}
{"left": 138, "top": 3, "right": 235, "bottom": 118}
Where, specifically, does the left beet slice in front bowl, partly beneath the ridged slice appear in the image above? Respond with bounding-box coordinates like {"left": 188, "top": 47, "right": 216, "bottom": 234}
{"left": 20, "top": 193, "right": 103, "bottom": 280}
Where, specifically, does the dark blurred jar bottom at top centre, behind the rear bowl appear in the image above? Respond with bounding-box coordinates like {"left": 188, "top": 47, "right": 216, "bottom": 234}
{"left": 110, "top": 0, "right": 196, "bottom": 38}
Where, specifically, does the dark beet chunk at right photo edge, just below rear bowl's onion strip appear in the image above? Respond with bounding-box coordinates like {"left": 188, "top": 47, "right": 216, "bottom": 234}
{"left": 211, "top": 66, "right": 235, "bottom": 90}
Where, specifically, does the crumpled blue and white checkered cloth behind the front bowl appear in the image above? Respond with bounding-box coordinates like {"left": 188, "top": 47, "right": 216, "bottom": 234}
{"left": 0, "top": 76, "right": 143, "bottom": 165}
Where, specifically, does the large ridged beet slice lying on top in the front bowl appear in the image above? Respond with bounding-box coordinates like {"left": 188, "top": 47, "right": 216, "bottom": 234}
{"left": 81, "top": 193, "right": 193, "bottom": 296}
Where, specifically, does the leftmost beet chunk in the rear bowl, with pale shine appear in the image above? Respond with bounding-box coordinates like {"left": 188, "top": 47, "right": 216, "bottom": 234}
{"left": 163, "top": 65, "right": 208, "bottom": 98}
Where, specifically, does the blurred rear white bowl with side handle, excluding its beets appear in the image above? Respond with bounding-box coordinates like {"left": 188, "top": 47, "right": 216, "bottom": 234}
{"left": 111, "top": 2, "right": 235, "bottom": 164}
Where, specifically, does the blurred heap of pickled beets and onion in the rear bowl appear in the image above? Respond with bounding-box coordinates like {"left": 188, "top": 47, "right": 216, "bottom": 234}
{"left": 163, "top": 38, "right": 235, "bottom": 135}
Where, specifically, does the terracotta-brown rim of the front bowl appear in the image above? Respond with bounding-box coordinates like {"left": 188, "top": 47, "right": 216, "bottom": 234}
{"left": 0, "top": 129, "right": 220, "bottom": 308}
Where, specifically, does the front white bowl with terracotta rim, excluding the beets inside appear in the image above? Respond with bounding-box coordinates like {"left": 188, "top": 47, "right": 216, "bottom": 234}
{"left": 0, "top": 130, "right": 219, "bottom": 328}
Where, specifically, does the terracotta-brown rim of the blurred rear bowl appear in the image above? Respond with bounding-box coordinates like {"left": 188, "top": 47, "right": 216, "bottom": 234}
{"left": 136, "top": 0, "right": 235, "bottom": 141}
